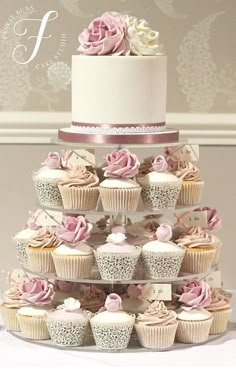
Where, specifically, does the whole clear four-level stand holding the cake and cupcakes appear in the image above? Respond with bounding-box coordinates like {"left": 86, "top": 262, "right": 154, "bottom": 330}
{"left": 8, "top": 140, "right": 225, "bottom": 352}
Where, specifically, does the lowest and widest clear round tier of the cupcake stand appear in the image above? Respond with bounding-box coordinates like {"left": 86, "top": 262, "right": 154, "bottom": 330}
{"left": 8, "top": 330, "right": 228, "bottom": 353}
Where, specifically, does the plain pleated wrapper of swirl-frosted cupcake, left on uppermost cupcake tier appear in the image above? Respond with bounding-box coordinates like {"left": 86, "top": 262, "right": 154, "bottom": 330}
{"left": 58, "top": 185, "right": 99, "bottom": 210}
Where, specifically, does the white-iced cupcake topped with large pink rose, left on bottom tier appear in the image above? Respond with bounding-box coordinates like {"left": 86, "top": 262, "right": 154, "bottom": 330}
{"left": 17, "top": 277, "right": 54, "bottom": 340}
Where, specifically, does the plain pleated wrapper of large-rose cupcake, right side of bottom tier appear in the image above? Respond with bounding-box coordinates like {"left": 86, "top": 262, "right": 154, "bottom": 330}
{"left": 176, "top": 317, "right": 213, "bottom": 344}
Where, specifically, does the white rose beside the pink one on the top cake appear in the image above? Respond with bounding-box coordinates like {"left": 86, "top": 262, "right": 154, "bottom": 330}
{"left": 125, "top": 16, "right": 162, "bottom": 55}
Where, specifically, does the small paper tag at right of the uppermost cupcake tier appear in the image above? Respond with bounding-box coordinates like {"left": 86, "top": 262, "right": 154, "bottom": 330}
{"left": 168, "top": 144, "right": 199, "bottom": 162}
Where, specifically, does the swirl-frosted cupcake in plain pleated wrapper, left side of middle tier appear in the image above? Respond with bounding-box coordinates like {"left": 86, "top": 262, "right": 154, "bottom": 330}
{"left": 26, "top": 227, "right": 61, "bottom": 273}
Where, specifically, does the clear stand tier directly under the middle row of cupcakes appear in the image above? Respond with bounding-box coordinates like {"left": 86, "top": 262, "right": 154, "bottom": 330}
{"left": 22, "top": 266, "right": 216, "bottom": 285}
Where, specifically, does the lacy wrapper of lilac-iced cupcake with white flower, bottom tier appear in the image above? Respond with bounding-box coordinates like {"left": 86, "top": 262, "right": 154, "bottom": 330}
{"left": 46, "top": 318, "right": 88, "bottom": 347}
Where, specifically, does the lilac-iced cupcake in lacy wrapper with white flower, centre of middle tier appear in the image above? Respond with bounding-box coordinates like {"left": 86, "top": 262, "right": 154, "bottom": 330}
{"left": 94, "top": 232, "right": 141, "bottom": 281}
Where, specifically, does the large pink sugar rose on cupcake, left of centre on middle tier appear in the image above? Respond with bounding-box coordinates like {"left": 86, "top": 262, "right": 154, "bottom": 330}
{"left": 58, "top": 215, "right": 93, "bottom": 246}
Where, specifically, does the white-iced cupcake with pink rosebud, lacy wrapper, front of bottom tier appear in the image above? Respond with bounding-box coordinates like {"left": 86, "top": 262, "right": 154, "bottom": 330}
{"left": 90, "top": 294, "right": 135, "bottom": 350}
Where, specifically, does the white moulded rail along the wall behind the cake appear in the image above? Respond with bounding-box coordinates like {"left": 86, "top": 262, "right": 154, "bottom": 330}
{"left": 0, "top": 112, "right": 236, "bottom": 146}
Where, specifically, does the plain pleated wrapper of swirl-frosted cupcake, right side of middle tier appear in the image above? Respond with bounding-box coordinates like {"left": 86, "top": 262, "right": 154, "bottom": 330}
{"left": 180, "top": 247, "right": 216, "bottom": 273}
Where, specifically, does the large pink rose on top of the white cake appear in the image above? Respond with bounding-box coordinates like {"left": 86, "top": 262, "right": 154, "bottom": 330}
{"left": 78, "top": 12, "right": 130, "bottom": 55}
